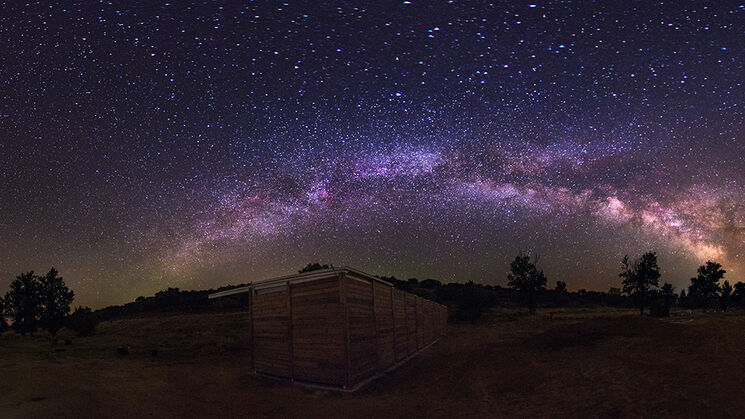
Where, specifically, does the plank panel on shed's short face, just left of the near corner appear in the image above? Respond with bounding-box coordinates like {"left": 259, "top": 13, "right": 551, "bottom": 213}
{"left": 290, "top": 276, "right": 347, "bottom": 386}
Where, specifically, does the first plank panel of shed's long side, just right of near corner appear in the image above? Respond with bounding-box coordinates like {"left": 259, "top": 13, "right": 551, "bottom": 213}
{"left": 344, "top": 278, "right": 377, "bottom": 385}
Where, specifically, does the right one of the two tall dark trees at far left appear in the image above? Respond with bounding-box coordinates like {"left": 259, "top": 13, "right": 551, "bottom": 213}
{"left": 39, "top": 268, "right": 75, "bottom": 335}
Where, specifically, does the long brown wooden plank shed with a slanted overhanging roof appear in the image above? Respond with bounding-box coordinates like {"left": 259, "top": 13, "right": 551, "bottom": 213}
{"left": 210, "top": 267, "right": 447, "bottom": 389}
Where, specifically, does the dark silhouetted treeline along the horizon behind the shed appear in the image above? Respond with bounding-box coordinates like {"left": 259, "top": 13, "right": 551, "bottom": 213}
{"left": 7, "top": 252, "right": 745, "bottom": 331}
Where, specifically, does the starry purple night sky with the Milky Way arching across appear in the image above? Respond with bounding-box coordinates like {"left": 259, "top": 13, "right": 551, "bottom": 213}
{"left": 0, "top": 0, "right": 745, "bottom": 307}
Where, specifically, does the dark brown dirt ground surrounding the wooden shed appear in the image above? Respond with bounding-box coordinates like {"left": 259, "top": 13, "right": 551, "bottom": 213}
{"left": 0, "top": 309, "right": 745, "bottom": 418}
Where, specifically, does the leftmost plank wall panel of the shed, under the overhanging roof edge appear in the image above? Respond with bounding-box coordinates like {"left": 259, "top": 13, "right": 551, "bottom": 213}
{"left": 252, "top": 289, "right": 291, "bottom": 378}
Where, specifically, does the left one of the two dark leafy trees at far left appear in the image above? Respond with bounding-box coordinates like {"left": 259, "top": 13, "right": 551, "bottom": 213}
{"left": 5, "top": 271, "right": 41, "bottom": 335}
